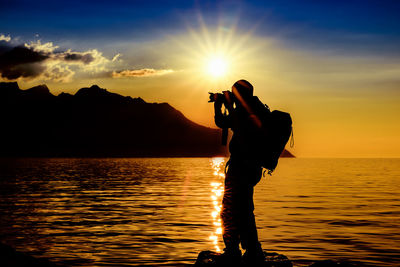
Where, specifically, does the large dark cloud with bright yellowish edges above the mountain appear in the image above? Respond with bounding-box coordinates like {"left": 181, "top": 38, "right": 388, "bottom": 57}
{"left": 0, "top": 35, "right": 120, "bottom": 82}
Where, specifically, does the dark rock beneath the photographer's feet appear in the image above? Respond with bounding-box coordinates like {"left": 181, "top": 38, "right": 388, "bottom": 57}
{"left": 194, "top": 251, "right": 293, "bottom": 267}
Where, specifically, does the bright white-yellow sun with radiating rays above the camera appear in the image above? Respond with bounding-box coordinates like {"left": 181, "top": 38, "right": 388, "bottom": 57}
{"left": 173, "top": 15, "right": 257, "bottom": 88}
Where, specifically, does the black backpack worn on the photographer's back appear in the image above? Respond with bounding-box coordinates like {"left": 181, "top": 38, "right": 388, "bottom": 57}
{"left": 255, "top": 101, "right": 293, "bottom": 175}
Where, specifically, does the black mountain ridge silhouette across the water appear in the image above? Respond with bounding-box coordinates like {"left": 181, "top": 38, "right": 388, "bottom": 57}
{"left": 0, "top": 82, "right": 292, "bottom": 157}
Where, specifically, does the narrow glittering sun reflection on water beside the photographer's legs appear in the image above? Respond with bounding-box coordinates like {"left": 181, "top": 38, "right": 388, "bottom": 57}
{"left": 209, "top": 157, "right": 225, "bottom": 252}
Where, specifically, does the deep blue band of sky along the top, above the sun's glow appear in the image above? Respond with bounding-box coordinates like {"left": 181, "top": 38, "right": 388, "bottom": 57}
{"left": 0, "top": 0, "right": 400, "bottom": 54}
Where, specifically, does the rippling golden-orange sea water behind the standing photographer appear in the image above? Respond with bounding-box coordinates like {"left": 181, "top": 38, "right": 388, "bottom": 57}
{"left": 0, "top": 158, "right": 400, "bottom": 266}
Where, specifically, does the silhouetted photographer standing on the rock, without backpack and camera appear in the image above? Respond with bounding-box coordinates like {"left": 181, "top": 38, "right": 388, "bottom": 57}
{"left": 214, "top": 80, "right": 265, "bottom": 265}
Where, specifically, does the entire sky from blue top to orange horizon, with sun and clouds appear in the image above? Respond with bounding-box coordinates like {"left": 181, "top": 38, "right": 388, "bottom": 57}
{"left": 0, "top": 0, "right": 400, "bottom": 158}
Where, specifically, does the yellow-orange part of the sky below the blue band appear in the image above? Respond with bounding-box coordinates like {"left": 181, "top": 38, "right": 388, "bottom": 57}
{"left": 5, "top": 26, "right": 400, "bottom": 157}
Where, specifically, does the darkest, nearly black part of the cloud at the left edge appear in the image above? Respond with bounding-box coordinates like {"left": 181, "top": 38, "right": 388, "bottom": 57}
{"left": 0, "top": 45, "right": 49, "bottom": 80}
